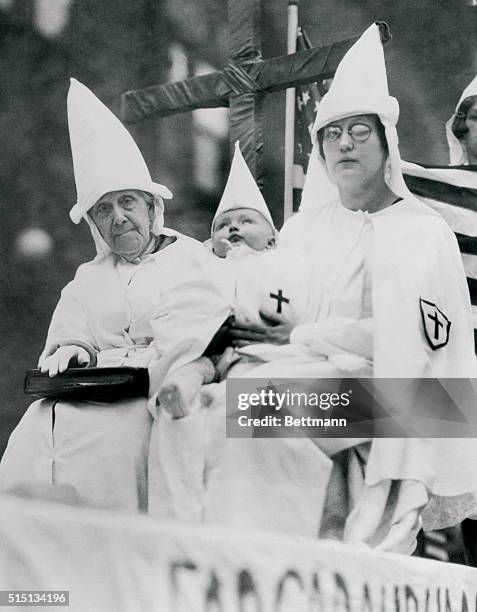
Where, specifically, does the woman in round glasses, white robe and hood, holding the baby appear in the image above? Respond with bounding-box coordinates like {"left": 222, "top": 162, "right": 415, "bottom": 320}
{"left": 151, "top": 25, "right": 476, "bottom": 552}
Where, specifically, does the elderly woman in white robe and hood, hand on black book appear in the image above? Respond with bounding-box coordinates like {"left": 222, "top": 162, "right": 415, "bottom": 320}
{"left": 0, "top": 79, "right": 227, "bottom": 512}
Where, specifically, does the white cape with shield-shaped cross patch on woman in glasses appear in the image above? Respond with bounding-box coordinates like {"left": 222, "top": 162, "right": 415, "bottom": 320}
{"left": 282, "top": 197, "right": 477, "bottom": 529}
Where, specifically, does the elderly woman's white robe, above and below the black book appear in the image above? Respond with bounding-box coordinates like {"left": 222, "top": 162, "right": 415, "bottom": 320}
{"left": 0, "top": 230, "right": 227, "bottom": 512}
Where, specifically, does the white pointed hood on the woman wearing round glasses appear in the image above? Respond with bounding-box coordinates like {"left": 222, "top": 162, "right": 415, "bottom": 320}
{"left": 300, "top": 24, "right": 410, "bottom": 210}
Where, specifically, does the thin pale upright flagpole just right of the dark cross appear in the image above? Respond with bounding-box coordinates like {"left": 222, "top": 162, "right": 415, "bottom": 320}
{"left": 283, "top": 0, "right": 298, "bottom": 222}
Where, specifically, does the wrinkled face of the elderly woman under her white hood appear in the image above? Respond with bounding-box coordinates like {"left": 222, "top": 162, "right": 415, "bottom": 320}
{"left": 89, "top": 189, "right": 154, "bottom": 261}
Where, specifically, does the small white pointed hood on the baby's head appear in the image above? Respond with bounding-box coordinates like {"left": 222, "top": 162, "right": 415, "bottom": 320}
{"left": 212, "top": 141, "right": 276, "bottom": 231}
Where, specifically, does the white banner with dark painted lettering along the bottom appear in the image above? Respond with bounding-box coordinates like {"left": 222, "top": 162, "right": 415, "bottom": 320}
{"left": 0, "top": 497, "right": 477, "bottom": 612}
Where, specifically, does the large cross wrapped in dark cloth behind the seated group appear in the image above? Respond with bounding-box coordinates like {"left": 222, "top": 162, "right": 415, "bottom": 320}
{"left": 121, "top": 0, "right": 355, "bottom": 186}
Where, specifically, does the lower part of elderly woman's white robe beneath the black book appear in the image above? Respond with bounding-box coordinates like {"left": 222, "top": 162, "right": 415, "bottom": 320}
{"left": 0, "top": 398, "right": 152, "bottom": 512}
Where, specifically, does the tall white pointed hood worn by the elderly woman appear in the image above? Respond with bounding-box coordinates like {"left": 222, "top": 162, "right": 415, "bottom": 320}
{"left": 68, "top": 79, "right": 172, "bottom": 237}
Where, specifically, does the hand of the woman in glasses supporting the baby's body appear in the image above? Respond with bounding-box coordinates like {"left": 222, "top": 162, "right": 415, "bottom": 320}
{"left": 229, "top": 310, "right": 293, "bottom": 347}
